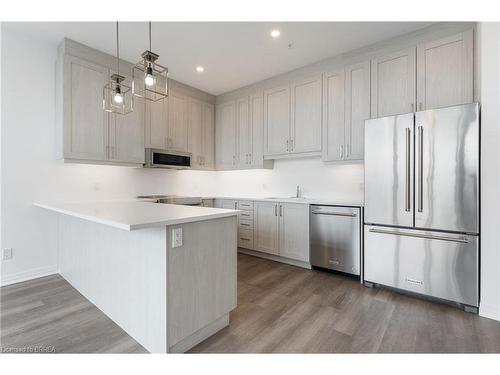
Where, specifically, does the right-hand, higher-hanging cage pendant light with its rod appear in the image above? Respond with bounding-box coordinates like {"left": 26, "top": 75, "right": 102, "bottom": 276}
{"left": 132, "top": 22, "right": 168, "bottom": 102}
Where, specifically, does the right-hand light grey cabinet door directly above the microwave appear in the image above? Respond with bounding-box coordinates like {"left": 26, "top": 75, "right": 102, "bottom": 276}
{"left": 167, "top": 89, "right": 188, "bottom": 151}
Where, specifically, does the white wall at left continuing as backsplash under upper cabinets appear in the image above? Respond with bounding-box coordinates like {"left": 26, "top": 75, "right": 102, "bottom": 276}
{"left": 1, "top": 25, "right": 363, "bottom": 284}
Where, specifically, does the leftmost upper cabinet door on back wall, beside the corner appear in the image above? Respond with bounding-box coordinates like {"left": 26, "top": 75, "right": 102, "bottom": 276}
{"left": 215, "top": 101, "right": 237, "bottom": 169}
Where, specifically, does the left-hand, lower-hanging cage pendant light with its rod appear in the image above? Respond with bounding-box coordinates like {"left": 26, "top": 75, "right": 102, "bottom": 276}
{"left": 102, "top": 22, "right": 134, "bottom": 115}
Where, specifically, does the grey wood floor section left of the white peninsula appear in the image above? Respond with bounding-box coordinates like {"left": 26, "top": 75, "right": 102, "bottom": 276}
{"left": 0, "top": 275, "right": 147, "bottom": 353}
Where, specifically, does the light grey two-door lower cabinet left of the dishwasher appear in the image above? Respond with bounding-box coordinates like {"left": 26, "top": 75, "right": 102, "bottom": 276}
{"left": 254, "top": 202, "right": 309, "bottom": 262}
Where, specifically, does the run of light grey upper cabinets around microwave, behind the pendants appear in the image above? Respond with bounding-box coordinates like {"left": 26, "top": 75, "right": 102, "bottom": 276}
{"left": 56, "top": 39, "right": 215, "bottom": 169}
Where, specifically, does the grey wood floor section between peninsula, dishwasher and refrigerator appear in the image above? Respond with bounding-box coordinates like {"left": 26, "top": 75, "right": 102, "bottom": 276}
{"left": 191, "top": 254, "right": 500, "bottom": 353}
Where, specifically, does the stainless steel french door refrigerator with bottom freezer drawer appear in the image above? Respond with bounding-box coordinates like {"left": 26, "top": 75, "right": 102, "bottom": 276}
{"left": 364, "top": 103, "right": 479, "bottom": 312}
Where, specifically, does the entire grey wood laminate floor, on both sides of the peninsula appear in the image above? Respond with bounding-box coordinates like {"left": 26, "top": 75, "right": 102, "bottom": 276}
{"left": 0, "top": 254, "right": 500, "bottom": 353}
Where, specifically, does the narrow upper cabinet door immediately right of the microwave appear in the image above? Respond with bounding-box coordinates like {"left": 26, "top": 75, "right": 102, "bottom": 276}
{"left": 188, "top": 97, "right": 203, "bottom": 169}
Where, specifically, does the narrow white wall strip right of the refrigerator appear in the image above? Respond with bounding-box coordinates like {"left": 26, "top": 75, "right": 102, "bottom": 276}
{"left": 479, "top": 22, "right": 500, "bottom": 320}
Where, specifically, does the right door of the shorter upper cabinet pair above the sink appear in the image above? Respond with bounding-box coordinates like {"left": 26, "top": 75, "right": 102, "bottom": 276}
{"left": 290, "top": 74, "right": 322, "bottom": 154}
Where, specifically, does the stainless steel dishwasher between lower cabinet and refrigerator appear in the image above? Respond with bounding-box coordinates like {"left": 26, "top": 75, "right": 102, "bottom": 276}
{"left": 309, "top": 205, "right": 361, "bottom": 276}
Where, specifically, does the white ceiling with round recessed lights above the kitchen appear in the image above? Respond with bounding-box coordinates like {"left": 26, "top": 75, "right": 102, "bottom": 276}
{"left": 4, "top": 22, "right": 430, "bottom": 95}
